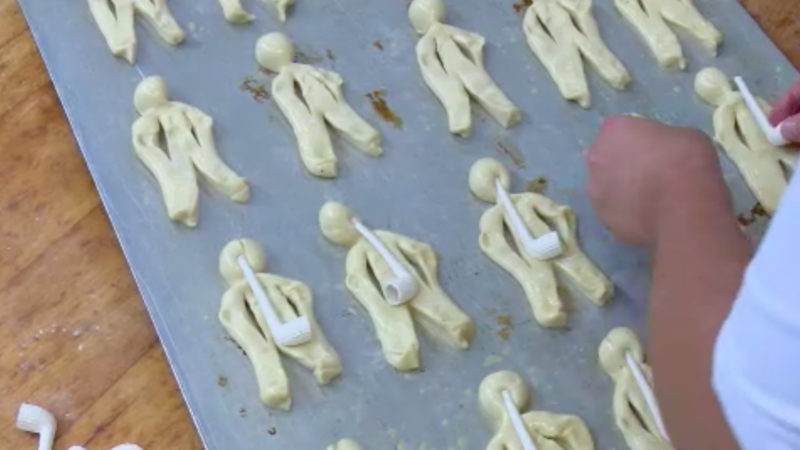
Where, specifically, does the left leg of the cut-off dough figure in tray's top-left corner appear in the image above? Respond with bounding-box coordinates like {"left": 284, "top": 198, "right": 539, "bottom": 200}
{"left": 88, "top": 0, "right": 136, "bottom": 63}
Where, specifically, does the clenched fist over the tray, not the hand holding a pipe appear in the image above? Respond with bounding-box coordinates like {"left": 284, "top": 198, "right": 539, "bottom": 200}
{"left": 586, "top": 116, "right": 727, "bottom": 244}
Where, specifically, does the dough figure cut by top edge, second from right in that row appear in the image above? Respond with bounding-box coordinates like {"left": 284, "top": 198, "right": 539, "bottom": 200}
{"left": 522, "top": 0, "right": 631, "bottom": 108}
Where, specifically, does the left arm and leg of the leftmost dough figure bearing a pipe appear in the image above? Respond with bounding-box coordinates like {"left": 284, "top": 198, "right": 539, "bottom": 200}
{"left": 219, "top": 281, "right": 292, "bottom": 409}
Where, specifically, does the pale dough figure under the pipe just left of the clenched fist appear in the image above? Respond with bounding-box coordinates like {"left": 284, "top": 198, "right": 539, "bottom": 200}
{"left": 469, "top": 158, "right": 614, "bottom": 327}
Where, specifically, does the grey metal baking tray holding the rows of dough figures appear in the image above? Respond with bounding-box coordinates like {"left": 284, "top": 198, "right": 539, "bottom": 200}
{"left": 19, "top": 0, "right": 796, "bottom": 449}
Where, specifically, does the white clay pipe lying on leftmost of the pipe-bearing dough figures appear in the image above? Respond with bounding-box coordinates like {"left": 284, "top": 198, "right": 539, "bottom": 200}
{"left": 236, "top": 255, "right": 311, "bottom": 347}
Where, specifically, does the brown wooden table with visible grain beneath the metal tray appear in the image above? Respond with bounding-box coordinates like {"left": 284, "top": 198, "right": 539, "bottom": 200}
{"left": 0, "top": 0, "right": 800, "bottom": 450}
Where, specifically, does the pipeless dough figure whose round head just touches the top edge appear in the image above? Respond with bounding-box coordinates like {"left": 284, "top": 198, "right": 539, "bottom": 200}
{"left": 408, "top": 0, "right": 520, "bottom": 137}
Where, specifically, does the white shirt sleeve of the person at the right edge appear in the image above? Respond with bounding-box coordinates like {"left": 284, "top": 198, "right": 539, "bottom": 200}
{"left": 712, "top": 173, "right": 800, "bottom": 450}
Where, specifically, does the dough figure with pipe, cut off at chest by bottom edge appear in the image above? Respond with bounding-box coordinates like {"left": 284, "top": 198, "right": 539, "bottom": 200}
{"left": 478, "top": 370, "right": 594, "bottom": 450}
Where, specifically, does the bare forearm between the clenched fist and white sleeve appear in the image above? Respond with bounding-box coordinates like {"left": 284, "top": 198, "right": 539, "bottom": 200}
{"left": 649, "top": 177, "right": 751, "bottom": 449}
